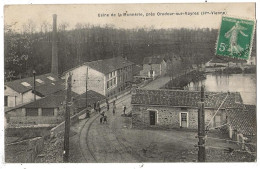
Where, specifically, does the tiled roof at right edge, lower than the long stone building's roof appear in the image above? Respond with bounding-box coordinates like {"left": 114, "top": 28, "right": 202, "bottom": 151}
{"left": 226, "top": 104, "right": 257, "bottom": 135}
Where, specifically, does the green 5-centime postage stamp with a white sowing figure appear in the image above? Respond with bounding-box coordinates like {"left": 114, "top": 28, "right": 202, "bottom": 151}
{"left": 216, "top": 17, "right": 255, "bottom": 60}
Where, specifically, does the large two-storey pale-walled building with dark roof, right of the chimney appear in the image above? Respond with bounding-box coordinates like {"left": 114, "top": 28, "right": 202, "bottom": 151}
{"left": 63, "top": 57, "right": 134, "bottom": 97}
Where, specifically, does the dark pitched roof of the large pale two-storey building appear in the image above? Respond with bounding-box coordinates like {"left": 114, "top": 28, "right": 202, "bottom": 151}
{"left": 62, "top": 57, "right": 134, "bottom": 76}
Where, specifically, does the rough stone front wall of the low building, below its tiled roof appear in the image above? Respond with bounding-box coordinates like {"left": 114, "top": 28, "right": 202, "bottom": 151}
{"left": 132, "top": 105, "right": 226, "bottom": 129}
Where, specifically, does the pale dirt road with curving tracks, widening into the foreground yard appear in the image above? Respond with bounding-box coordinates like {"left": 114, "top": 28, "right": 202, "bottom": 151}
{"left": 70, "top": 95, "right": 199, "bottom": 163}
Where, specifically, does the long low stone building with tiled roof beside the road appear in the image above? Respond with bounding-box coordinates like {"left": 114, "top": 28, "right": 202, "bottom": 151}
{"left": 131, "top": 89, "right": 242, "bottom": 129}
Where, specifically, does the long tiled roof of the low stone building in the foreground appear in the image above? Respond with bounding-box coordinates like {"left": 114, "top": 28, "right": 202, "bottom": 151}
{"left": 132, "top": 89, "right": 242, "bottom": 109}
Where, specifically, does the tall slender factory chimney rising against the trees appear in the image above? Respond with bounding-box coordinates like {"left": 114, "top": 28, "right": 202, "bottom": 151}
{"left": 51, "top": 14, "right": 59, "bottom": 76}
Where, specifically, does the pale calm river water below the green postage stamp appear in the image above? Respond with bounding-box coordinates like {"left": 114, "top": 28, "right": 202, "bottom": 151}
{"left": 185, "top": 74, "right": 257, "bottom": 105}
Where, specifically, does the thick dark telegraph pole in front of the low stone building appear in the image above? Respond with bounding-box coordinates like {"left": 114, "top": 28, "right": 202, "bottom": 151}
{"left": 198, "top": 85, "right": 206, "bottom": 162}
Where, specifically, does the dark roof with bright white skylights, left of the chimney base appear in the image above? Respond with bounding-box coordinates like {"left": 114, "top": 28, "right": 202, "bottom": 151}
{"left": 5, "top": 73, "right": 64, "bottom": 95}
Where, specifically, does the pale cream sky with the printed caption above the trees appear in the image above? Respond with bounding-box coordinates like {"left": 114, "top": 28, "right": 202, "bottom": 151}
{"left": 4, "top": 3, "right": 255, "bottom": 31}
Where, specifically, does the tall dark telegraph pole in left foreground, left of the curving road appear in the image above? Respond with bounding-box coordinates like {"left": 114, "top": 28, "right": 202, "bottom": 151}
{"left": 63, "top": 74, "right": 71, "bottom": 163}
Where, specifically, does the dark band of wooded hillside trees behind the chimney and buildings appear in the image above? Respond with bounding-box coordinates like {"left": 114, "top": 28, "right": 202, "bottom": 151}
{"left": 4, "top": 23, "right": 217, "bottom": 81}
